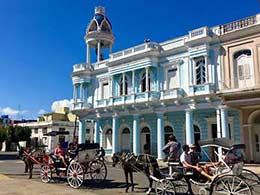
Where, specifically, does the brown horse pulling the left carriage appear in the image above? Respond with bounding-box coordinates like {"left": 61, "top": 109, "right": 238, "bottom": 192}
{"left": 18, "top": 147, "right": 43, "bottom": 179}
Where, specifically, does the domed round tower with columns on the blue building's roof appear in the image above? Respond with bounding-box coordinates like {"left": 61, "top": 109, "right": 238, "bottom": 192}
{"left": 84, "top": 6, "right": 115, "bottom": 64}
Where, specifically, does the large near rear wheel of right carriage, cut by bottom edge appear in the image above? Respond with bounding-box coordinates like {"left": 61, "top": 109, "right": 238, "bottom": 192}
{"left": 211, "top": 175, "right": 252, "bottom": 195}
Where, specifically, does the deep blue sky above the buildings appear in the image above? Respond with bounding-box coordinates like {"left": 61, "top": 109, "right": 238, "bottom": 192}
{"left": 0, "top": 0, "right": 260, "bottom": 118}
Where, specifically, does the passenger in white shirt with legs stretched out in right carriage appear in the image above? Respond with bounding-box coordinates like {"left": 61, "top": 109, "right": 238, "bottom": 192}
{"left": 180, "top": 145, "right": 215, "bottom": 181}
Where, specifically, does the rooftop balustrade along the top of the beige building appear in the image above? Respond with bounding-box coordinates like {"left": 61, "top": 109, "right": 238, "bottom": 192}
{"left": 220, "top": 16, "right": 258, "bottom": 34}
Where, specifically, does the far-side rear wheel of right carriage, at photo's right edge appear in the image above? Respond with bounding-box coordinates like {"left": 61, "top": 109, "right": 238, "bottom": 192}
{"left": 239, "top": 169, "right": 260, "bottom": 194}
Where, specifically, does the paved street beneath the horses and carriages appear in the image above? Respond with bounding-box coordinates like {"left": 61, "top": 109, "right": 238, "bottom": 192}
{"left": 0, "top": 153, "right": 260, "bottom": 195}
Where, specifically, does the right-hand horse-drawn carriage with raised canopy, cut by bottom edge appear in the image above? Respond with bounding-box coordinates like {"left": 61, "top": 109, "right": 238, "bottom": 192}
{"left": 151, "top": 138, "right": 260, "bottom": 195}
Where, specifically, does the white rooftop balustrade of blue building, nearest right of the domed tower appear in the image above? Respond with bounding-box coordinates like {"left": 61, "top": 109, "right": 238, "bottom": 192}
{"left": 110, "top": 42, "right": 160, "bottom": 59}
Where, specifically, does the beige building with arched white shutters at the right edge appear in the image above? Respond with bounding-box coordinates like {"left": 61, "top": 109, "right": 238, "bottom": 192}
{"left": 219, "top": 14, "right": 260, "bottom": 163}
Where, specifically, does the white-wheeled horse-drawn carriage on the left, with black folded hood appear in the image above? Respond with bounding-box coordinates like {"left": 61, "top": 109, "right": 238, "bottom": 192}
{"left": 40, "top": 144, "right": 107, "bottom": 188}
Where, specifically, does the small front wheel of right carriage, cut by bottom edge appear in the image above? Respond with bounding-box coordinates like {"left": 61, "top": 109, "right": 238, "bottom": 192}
{"left": 155, "top": 179, "right": 175, "bottom": 195}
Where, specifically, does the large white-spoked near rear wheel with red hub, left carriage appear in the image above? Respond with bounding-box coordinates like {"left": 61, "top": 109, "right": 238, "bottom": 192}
{"left": 67, "top": 161, "right": 84, "bottom": 188}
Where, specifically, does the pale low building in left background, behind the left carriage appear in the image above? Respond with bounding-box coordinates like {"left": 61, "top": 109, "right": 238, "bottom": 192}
{"left": 18, "top": 107, "right": 94, "bottom": 150}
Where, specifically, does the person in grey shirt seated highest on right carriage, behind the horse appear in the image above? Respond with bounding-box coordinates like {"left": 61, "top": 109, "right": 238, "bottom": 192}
{"left": 162, "top": 135, "right": 180, "bottom": 162}
